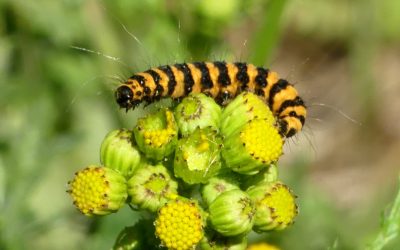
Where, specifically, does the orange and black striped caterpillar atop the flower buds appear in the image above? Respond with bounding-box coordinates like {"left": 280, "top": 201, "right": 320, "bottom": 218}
{"left": 115, "top": 61, "right": 307, "bottom": 138}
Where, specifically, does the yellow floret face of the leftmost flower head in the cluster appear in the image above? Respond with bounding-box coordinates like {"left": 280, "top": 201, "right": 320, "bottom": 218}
{"left": 69, "top": 167, "right": 109, "bottom": 215}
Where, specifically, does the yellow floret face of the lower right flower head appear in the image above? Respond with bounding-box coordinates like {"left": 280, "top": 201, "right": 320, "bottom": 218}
{"left": 260, "top": 183, "right": 297, "bottom": 227}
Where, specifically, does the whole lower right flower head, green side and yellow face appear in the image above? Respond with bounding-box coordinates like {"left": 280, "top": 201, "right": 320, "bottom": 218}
{"left": 247, "top": 182, "right": 297, "bottom": 232}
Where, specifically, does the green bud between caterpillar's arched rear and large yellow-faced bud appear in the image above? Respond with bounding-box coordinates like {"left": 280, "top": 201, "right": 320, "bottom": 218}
{"left": 221, "top": 92, "right": 275, "bottom": 136}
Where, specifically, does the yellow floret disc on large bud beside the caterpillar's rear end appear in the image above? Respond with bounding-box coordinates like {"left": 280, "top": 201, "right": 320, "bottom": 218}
{"left": 240, "top": 119, "right": 283, "bottom": 164}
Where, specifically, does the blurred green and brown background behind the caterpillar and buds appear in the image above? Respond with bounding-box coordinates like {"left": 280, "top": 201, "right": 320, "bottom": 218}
{"left": 0, "top": 0, "right": 400, "bottom": 249}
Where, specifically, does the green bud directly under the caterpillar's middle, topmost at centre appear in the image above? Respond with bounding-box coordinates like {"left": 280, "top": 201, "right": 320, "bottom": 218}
{"left": 174, "top": 93, "right": 221, "bottom": 136}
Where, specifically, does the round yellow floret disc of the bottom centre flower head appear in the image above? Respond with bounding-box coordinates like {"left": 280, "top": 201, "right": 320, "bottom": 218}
{"left": 155, "top": 200, "right": 203, "bottom": 250}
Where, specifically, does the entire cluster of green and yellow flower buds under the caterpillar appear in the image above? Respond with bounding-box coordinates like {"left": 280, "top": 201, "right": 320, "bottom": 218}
{"left": 68, "top": 92, "right": 297, "bottom": 250}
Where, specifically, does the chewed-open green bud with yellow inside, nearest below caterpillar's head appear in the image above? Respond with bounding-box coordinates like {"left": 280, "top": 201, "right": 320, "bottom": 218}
{"left": 133, "top": 109, "right": 178, "bottom": 161}
